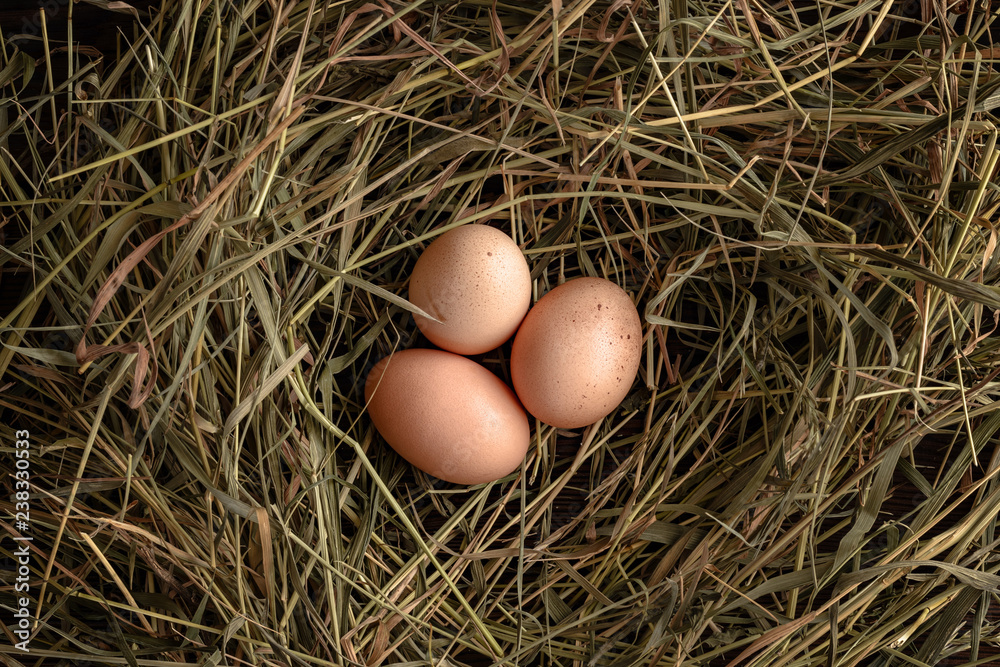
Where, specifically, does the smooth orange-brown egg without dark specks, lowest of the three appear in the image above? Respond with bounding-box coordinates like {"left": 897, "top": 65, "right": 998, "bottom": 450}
{"left": 365, "top": 349, "right": 530, "bottom": 484}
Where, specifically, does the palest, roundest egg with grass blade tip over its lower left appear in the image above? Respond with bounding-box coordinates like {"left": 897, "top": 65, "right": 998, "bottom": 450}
{"left": 409, "top": 225, "right": 531, "bottom": 354}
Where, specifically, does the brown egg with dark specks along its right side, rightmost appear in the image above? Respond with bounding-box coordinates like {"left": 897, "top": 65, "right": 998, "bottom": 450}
{"left": 510, "top": 278, "right": 642, "bottom": 428}
